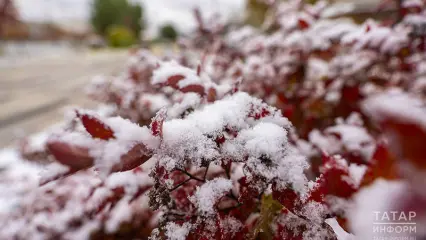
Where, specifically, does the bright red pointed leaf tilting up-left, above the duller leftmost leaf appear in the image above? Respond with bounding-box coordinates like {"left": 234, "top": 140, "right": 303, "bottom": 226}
{"left": 77, "top": 112, "right": 115, "bottom": 140}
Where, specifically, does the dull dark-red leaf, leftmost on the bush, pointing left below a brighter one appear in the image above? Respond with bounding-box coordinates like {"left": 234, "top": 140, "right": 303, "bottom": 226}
{"left": 46, "top": 141, "right": 94, "bottom": 170}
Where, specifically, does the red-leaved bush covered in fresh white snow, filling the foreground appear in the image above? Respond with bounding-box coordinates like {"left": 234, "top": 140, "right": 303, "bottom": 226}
{"left": 0, "top": 1, "right": 426, "bottom": 240}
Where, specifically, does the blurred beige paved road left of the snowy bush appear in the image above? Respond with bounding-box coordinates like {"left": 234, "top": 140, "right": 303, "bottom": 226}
{"left": 0, "top": 51, "right": 128, "bottom": 148}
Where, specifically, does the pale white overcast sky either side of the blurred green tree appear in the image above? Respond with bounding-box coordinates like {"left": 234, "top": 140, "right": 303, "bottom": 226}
{"left": 15, "top": 0, "right": 244, "bottom": 35}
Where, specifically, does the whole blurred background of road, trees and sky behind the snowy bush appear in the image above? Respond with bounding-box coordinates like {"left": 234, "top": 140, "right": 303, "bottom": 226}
{"left": 0, "top": 0, "right": 388, "bottom": 147}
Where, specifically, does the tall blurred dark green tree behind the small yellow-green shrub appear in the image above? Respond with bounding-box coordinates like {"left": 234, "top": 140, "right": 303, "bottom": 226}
{"left": 91, "top": 0, "right": 143, "bottom": 36}
